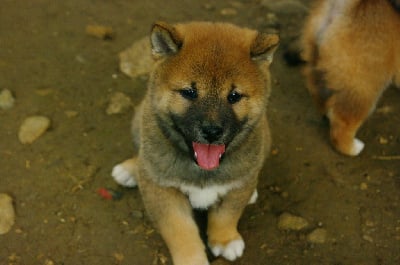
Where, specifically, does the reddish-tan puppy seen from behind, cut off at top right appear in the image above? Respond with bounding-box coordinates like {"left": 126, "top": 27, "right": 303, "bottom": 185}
{"left": 302, "top": 0, "right": 400, "bottom": 156}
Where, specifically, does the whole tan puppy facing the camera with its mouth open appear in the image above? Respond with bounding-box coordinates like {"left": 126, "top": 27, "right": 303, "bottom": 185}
{"left": 112, "top": 22, "right": 279, "bottom": 265}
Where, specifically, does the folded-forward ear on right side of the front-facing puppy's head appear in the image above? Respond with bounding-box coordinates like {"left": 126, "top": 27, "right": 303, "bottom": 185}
{"left": 250, "top": 33, "right": 279, "bottom": 63}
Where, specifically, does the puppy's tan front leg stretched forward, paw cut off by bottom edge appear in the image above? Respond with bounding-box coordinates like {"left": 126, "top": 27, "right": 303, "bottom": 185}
{"left": 138, "top": 177, "right": 209, "bottom": 265}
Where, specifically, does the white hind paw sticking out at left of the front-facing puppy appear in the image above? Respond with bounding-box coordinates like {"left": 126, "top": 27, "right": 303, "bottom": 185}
{"left": 111, "top": 157, "right": 137, "bottom": 187}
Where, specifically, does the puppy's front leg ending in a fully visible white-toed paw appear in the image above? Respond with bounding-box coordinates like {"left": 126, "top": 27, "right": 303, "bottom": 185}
{"left": 207, "top": 182, "right": 256, "bottom": 261}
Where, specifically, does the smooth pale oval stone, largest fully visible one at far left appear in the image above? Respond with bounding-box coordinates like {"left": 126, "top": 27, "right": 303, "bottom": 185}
{"left": 18, "top": 116, "right": 50, "bottom": 144}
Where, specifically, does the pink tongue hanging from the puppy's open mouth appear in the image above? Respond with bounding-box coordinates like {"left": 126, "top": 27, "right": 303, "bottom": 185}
{"left": 192, "top": 142, "right": 225, "bottom": 170}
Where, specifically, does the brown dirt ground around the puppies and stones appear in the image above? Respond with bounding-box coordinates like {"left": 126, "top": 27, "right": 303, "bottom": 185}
{"left": 0, "top": 0, "right": 400, "bottom": 265}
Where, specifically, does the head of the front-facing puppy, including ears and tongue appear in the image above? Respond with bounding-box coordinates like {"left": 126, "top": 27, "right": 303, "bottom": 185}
{"left": 150, "top": 23, "right": 278, "bottom": 170}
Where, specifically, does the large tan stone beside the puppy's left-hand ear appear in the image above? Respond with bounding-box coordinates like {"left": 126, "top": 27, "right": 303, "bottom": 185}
{"left": 119, "top": 37, "right": 154, "bottom": 78}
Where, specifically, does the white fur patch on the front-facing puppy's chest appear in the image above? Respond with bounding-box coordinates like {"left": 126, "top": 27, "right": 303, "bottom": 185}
{"left": 180, "top": 183, "right": 239, "bottom": 209}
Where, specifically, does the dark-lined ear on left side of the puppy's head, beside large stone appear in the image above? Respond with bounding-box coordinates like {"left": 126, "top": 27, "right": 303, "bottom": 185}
{"left": 150, "top": 22, "right": 182, "bottom": 57}
